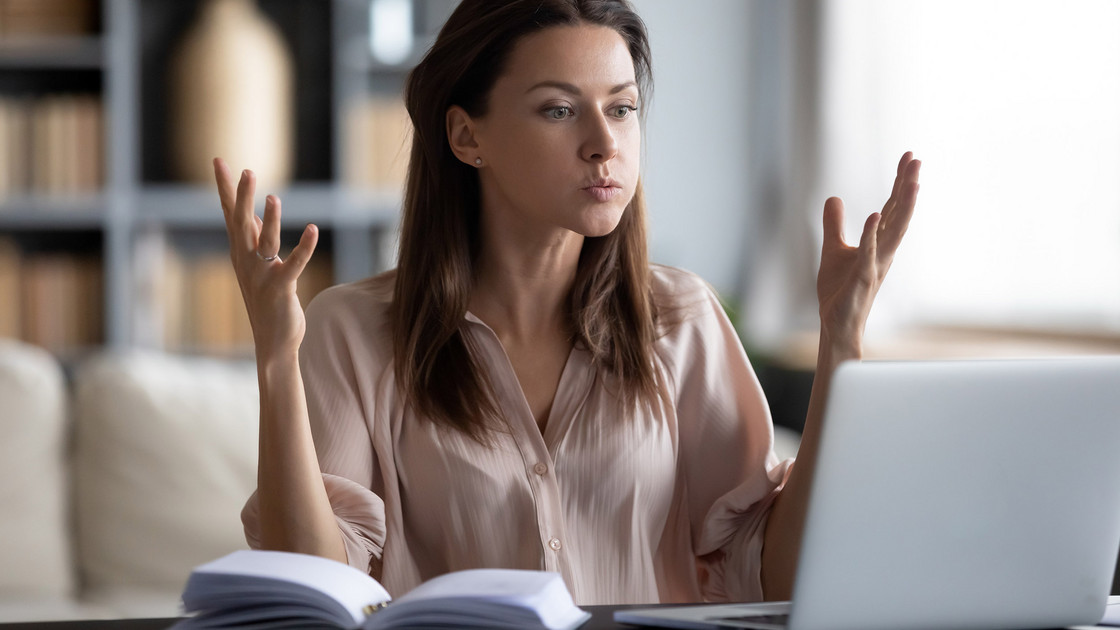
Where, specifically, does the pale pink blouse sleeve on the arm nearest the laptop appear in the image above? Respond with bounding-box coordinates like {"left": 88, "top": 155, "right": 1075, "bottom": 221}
{"left": 666, "top": 272, "right": 793, "bottom": 601}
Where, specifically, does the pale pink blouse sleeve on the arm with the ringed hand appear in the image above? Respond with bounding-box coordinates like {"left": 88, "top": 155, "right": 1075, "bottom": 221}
{"left": 241, "top": 284, "right": 385, "bottom": 577}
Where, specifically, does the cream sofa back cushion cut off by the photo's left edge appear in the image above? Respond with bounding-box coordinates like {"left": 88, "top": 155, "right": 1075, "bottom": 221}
{"left": 0, "top": 340, "right": 75, "bottom": 602}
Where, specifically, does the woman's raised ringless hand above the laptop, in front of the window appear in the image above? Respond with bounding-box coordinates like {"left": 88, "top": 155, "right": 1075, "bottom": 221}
{"left": 816, "top": 151, "right": 922, "bottom": 361}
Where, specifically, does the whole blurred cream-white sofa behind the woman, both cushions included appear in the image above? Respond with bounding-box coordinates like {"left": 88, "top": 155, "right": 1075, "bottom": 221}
{"left": 0, "top": 340, "right": 797, "bottom": 622}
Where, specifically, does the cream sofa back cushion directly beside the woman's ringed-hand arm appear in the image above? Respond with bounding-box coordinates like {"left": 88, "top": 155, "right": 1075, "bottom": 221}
{"left": 74, "top": 351, "right": 258, "bottom": 602}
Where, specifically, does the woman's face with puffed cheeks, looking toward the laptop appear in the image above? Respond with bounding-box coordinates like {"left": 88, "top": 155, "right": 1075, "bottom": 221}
{"left": 475, "top": 25, "right": 641, "bottom": 237}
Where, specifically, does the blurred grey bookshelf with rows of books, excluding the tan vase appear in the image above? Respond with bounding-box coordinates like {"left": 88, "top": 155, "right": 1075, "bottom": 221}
{"left": 0, "top": 0, "right": 456, "bottom": 356}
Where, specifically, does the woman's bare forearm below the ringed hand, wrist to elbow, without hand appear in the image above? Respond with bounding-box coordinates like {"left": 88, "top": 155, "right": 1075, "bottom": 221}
{"left": 256, "top": 353, "right": 346, "bottom": 562}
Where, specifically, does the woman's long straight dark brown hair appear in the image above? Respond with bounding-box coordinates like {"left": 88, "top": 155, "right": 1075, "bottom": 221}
{"left": 393, "top": 0, "right": 656, "bottom": 441}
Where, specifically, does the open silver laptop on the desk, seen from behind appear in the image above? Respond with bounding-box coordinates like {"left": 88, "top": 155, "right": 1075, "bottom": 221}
{"left": 615, "top": 356, "right": 1120, "bottom": 630}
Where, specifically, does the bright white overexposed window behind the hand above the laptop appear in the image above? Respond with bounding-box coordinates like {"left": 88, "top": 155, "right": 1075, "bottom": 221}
{"left": 820, "top": 0, "right": 1120, "bottom": 333}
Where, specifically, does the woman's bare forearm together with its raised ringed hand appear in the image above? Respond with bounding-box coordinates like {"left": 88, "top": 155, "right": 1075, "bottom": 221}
{"left": 214, "top": 158, "right": 346, "bottom": 562}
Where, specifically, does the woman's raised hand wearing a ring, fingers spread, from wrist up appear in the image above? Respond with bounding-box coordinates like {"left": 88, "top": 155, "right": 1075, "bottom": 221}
{"left": 214, "top": 158, "right": 319, "bottom": 360}
